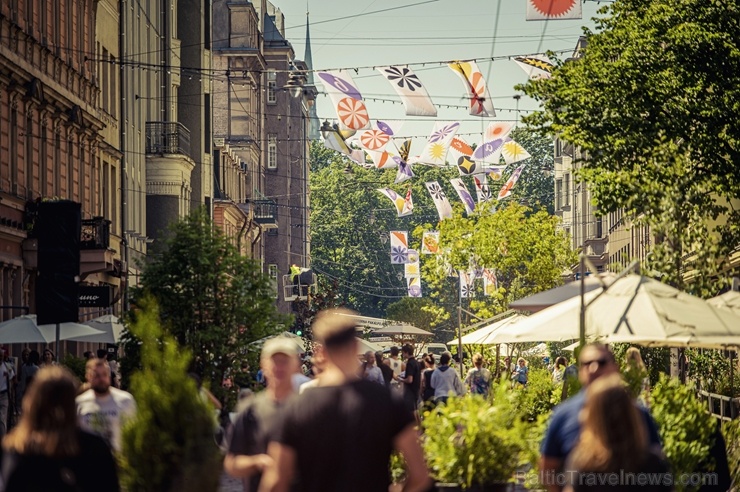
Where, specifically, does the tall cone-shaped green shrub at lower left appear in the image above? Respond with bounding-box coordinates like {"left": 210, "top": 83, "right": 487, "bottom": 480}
{"left": 121, "top": 300, "right": 221, "bottom": 492}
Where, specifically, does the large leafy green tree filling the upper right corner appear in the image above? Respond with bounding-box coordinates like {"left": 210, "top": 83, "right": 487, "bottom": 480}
{"left": 524, "top": 0, "right": 740, "bottom": 294}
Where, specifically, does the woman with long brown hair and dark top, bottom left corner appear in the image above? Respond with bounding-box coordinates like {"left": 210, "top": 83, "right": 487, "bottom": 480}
{"left": 2, "top": 366, "right": 119, "bottom": 492}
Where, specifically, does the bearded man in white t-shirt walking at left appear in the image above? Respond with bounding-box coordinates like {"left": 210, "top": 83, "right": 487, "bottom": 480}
{"left": 77, "top": 359, "right": 136, "bottom": 452}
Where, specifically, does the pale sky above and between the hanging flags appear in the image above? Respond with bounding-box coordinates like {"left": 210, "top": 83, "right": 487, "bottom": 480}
{"left": 271, "top": 0, "right": 604, "bottom": 146}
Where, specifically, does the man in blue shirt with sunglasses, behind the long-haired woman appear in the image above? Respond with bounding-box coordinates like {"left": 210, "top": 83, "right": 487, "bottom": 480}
{"left": 540, "top": 343, "right": 660, "bottom": 492}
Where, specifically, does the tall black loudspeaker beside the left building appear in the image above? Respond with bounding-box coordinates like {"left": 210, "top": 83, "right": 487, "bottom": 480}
{"left": 34, "top": 200, "right": 81, "bottom": 325}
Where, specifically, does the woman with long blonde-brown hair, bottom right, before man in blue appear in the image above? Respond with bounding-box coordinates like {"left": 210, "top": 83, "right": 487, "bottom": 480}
{"left": 565, "top": 374, "right": 672, "bottom": 492}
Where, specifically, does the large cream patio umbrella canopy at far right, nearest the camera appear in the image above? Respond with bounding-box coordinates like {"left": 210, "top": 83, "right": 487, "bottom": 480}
{"left": 494, "top": 275, "right": 740, "bottom": 348}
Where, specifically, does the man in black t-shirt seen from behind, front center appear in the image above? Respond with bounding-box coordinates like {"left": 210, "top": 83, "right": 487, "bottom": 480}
{"left": 259, "top": 310, "right": 431, "bottom": 492}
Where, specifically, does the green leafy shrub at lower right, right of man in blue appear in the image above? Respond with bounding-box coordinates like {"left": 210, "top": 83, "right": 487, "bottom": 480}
{"left": 650, "top": 375, "right": 717, "bottom": 492}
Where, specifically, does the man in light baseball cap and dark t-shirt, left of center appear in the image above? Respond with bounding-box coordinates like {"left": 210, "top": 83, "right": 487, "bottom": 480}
{"left": 224, "top": 337, "right": 298, "bottom": 492}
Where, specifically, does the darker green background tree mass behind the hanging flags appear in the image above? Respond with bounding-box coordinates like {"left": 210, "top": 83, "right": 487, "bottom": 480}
{"left": 310, "top": 129, "right": 553, "bottom": 320}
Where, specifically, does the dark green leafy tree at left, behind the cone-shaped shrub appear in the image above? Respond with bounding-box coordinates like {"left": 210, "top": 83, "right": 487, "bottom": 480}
{"left": 135, "top": 210, "right": 290, "bottom": 390}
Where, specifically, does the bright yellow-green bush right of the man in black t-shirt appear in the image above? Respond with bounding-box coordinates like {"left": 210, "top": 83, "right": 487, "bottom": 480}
{"left": 422, "top": 384, "right": 527, "bottom": 487}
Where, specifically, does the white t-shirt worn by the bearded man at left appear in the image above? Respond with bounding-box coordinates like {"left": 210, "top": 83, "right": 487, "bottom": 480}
{"left": 77, "top": 386, "right": 136, "bottom": 452}
